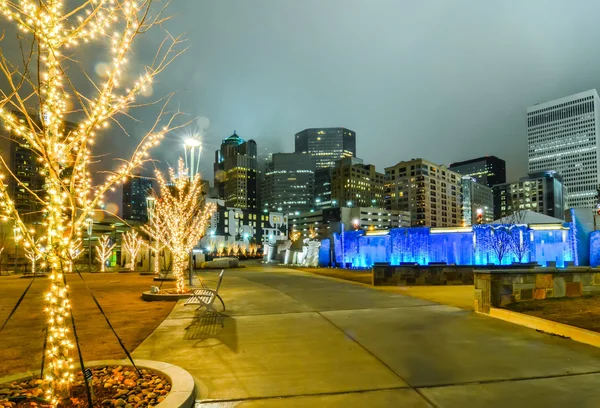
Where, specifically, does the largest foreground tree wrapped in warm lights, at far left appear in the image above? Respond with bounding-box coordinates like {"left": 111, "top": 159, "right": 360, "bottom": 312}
{"left": 0, "top": 0, "right": 183, "bottom": 405}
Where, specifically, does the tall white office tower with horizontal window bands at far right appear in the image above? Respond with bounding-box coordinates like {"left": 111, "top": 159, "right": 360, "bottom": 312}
{"left": 527, "top": 89, "right": 600, "bottom": 209}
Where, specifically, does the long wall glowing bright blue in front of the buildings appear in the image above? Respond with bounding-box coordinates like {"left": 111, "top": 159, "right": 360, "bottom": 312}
{"left": 333, "top": 223, "right": 576, "bottom": 268}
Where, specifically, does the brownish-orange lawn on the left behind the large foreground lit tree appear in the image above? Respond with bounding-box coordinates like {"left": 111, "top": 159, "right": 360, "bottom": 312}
{"left": 0, "top": 273, "right": 176, "bottom": 375}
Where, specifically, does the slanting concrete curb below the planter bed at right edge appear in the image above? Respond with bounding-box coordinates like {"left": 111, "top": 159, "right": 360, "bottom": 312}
{"left": 490, "top": 307, "right": 600, "bottom": 347}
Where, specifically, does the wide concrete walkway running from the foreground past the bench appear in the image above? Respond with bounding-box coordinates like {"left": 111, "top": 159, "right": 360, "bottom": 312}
{"left": 134, "top": 267, "right": 600, "bottom": 408}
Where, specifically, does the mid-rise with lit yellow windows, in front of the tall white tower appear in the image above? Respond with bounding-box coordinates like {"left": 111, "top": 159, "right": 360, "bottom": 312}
{"left": 493, "top": 171, "right": 566, "bottom": 220}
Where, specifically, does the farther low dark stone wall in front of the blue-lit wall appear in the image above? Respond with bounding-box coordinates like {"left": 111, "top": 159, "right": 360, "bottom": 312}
{"left": 372, "top": 263, "right": 473, "bottom": 286}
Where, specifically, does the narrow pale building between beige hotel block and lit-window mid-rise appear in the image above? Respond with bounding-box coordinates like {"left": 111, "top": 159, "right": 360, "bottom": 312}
{"left": 460, "top": 176, "right": 494, "bottom": 226}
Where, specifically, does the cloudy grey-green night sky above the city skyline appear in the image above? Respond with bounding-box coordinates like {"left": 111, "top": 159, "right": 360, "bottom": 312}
{"left": 3, "top": 0, "right": 600, "bottom": 188}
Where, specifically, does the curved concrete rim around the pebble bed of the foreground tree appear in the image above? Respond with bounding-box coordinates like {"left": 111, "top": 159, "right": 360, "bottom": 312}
{"left": 0, "top": 360, "right": 196, "bottom": 408}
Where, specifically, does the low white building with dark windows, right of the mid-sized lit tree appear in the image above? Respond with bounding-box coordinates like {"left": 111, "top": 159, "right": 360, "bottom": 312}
{"left": 203, "top": 198, "right": 288, "bottom": 243}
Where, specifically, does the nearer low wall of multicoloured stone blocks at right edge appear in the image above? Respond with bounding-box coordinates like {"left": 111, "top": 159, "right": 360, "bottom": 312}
{"left": 474, "top": 267, "right": 600, "bottom": 313}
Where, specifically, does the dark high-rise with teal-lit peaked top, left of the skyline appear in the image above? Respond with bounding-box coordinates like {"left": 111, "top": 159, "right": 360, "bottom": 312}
{"left": 214, "top": 132, "right": 258, "bottom": 209}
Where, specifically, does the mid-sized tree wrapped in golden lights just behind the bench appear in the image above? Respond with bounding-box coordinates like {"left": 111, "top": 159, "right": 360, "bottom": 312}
{"left": 142, "top": 159, "right": 215, "bottom": 293}
